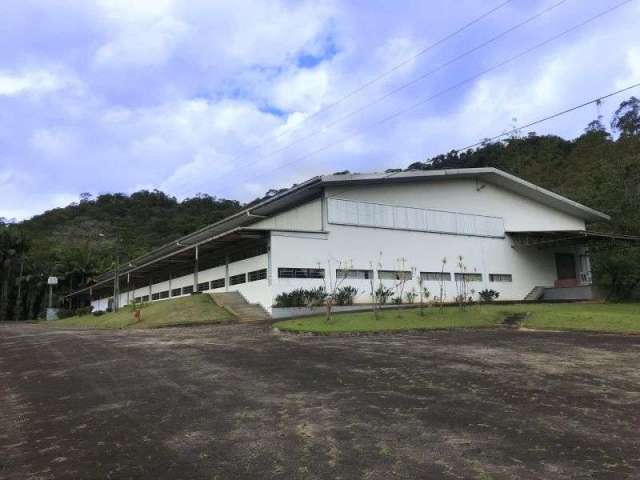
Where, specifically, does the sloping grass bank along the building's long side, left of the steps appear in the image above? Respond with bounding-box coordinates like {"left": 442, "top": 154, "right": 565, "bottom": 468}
{"left": 46, "top": 295, "right": 234, "bottom": 329}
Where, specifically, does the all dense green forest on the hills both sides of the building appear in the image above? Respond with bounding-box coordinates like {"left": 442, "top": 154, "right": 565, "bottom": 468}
{"left": 0, "top": 97, "right": 640, "bottom": 321}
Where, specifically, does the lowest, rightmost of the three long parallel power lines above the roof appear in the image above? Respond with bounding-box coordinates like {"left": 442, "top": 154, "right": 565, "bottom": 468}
{"left": 234, "top": 0, "right": 633, "bottom": 186}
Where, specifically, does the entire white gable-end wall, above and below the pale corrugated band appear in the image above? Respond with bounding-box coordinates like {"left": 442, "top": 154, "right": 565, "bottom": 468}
{"left": 271, "top": 179, "right": 585, "bottom": 302}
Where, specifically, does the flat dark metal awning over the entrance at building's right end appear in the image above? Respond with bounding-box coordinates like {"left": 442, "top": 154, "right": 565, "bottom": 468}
{"left": 507, "top": 230, "right": 640, "bottom": 248}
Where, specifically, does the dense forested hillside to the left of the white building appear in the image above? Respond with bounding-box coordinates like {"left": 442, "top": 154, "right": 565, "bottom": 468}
{"left": 0, "top": 190, "right": 241, "bottom": 321}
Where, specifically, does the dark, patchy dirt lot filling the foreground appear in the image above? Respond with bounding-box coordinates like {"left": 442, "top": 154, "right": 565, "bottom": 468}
{"left": 0, "top": 325, "right": 640, "bottom": 480}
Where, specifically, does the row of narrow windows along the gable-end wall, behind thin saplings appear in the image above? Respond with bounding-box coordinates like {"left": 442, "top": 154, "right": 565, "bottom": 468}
{"left": 278, "top": 268, "right": 513, "bottom": 282}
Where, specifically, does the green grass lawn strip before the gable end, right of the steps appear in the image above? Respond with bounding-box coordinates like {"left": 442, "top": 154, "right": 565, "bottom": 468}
{"left": 274, "top": 303, "right": 640, "bottom": 334}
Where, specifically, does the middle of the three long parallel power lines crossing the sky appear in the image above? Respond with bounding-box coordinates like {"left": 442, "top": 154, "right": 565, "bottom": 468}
{"left": 216, "top": 0, "right": 568, "bottom": 186}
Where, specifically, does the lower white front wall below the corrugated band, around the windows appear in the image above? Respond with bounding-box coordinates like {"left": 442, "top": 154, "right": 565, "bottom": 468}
{"left": 271, "top": 225, "right": 556, "bottom": 302}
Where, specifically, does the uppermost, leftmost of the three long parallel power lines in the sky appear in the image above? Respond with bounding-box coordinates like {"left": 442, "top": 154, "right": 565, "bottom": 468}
{"left": 210, "top": 0, "right": 516, "bottom": 178}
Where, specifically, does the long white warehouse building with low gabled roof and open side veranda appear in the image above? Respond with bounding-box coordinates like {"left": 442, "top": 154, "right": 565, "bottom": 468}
{"left": 74, "top": 168, "right": 609, "bottom": 312}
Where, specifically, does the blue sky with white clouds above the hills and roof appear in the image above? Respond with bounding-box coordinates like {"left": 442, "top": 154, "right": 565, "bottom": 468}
{"left": 0, "top": 0, "right": 640, "bottom": 220}
